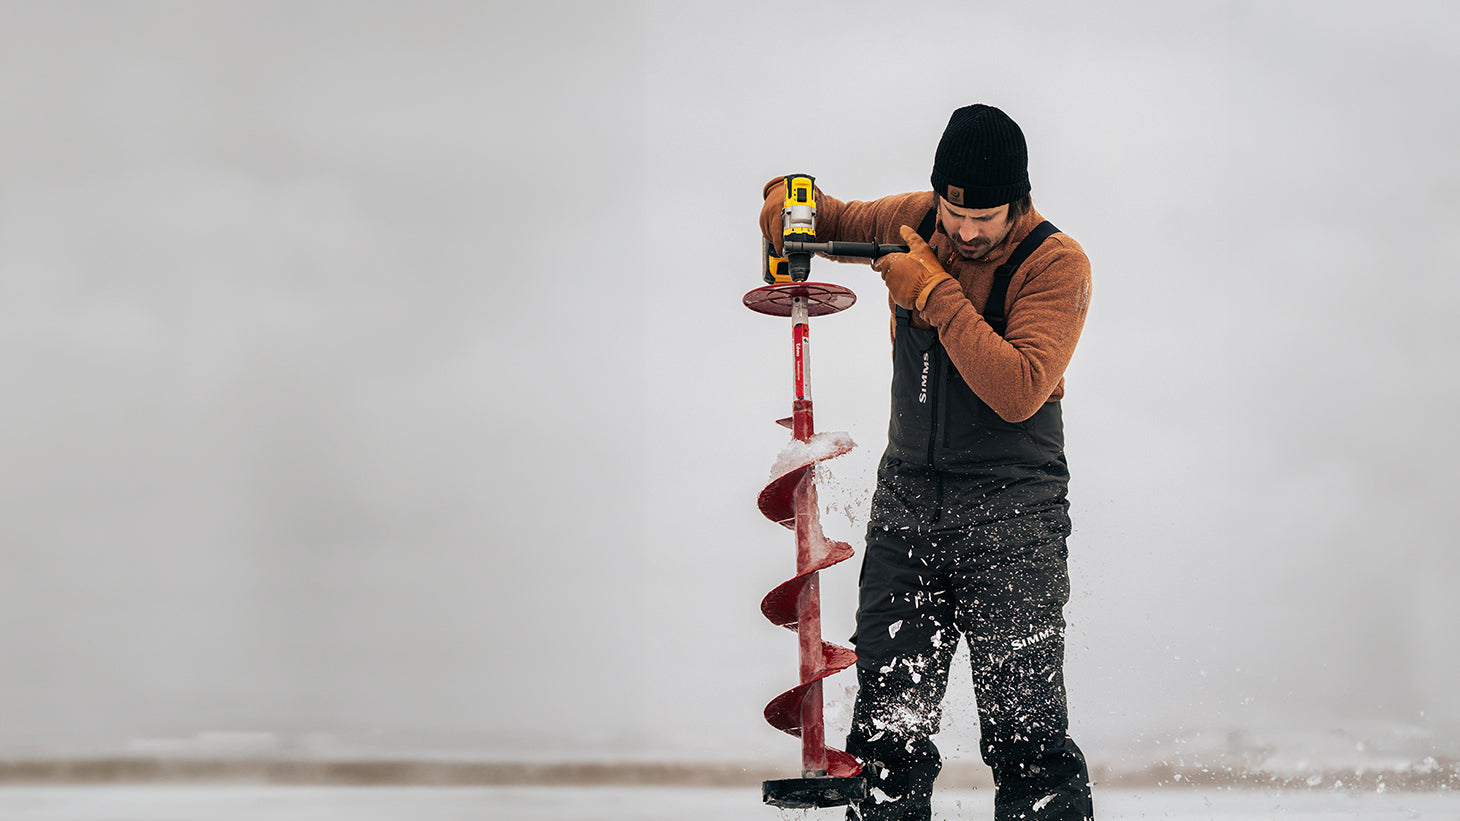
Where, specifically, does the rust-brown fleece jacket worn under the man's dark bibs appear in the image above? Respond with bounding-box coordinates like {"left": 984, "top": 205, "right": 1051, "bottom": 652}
{"left": 761, "top": 178, "right": 1091, "bottom": 422}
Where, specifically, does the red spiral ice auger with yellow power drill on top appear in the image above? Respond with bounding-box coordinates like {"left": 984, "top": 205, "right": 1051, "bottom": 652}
{"left": 745, "top": 174, "right": 875, "bottom": 809}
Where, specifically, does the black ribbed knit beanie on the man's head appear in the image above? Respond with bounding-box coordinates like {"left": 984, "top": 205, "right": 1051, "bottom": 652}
{"left": 933, "top": 104, "right": 1029, "bottom": 207}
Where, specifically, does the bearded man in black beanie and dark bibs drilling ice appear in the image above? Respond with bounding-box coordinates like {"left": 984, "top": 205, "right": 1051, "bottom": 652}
{"left": 761, "top": 105, "right": 1094, "bottom": 821}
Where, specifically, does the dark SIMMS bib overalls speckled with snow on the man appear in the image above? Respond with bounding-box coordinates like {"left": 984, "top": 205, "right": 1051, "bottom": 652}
{"left": 847, "top": 222, "right": 1092, "bottom": 821}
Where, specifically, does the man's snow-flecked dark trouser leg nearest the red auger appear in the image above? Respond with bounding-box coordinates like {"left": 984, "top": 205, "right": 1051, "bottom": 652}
{"left": 847, "top": 527, "right": 958, "bottom": 821}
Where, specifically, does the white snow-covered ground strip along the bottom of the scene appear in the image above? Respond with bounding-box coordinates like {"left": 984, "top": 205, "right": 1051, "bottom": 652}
{"left": 0, "top": 786, "right": 1460, "bottom": 821}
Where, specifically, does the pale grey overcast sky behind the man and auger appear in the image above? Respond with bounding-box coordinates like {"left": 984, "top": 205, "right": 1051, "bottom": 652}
{"left": 0, "top": 0, "right": 1460, "bottom": 758}
